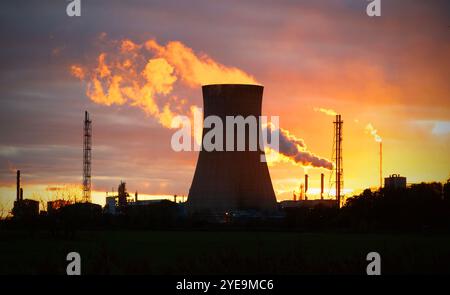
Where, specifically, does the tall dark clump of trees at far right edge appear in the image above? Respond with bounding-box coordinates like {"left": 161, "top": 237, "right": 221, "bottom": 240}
{"left": 338, "top": 183, "right": 450, "bottom": 231}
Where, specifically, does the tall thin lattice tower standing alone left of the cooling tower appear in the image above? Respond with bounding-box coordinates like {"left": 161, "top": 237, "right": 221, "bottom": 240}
{"left": 83, "top": 111, "right": 92, "bottom": 203}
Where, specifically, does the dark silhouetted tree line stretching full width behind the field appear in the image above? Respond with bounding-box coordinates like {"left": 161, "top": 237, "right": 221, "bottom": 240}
{"left": 0, "top": 179, "right": 450, "bottom": 236}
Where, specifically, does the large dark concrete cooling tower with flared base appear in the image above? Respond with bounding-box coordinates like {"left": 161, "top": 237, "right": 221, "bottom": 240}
{"left": 187, "top": 84, "right": 276, "bottom": 214}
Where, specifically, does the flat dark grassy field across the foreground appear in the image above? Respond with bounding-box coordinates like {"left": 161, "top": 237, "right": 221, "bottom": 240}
{"left": 0, "top": 231, "right": 450, "bottom": 274}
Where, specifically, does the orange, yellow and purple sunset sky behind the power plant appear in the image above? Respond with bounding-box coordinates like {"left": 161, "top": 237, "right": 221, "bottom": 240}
{"left": 0, "top": 0, "right": 450, "bottom": 213}
